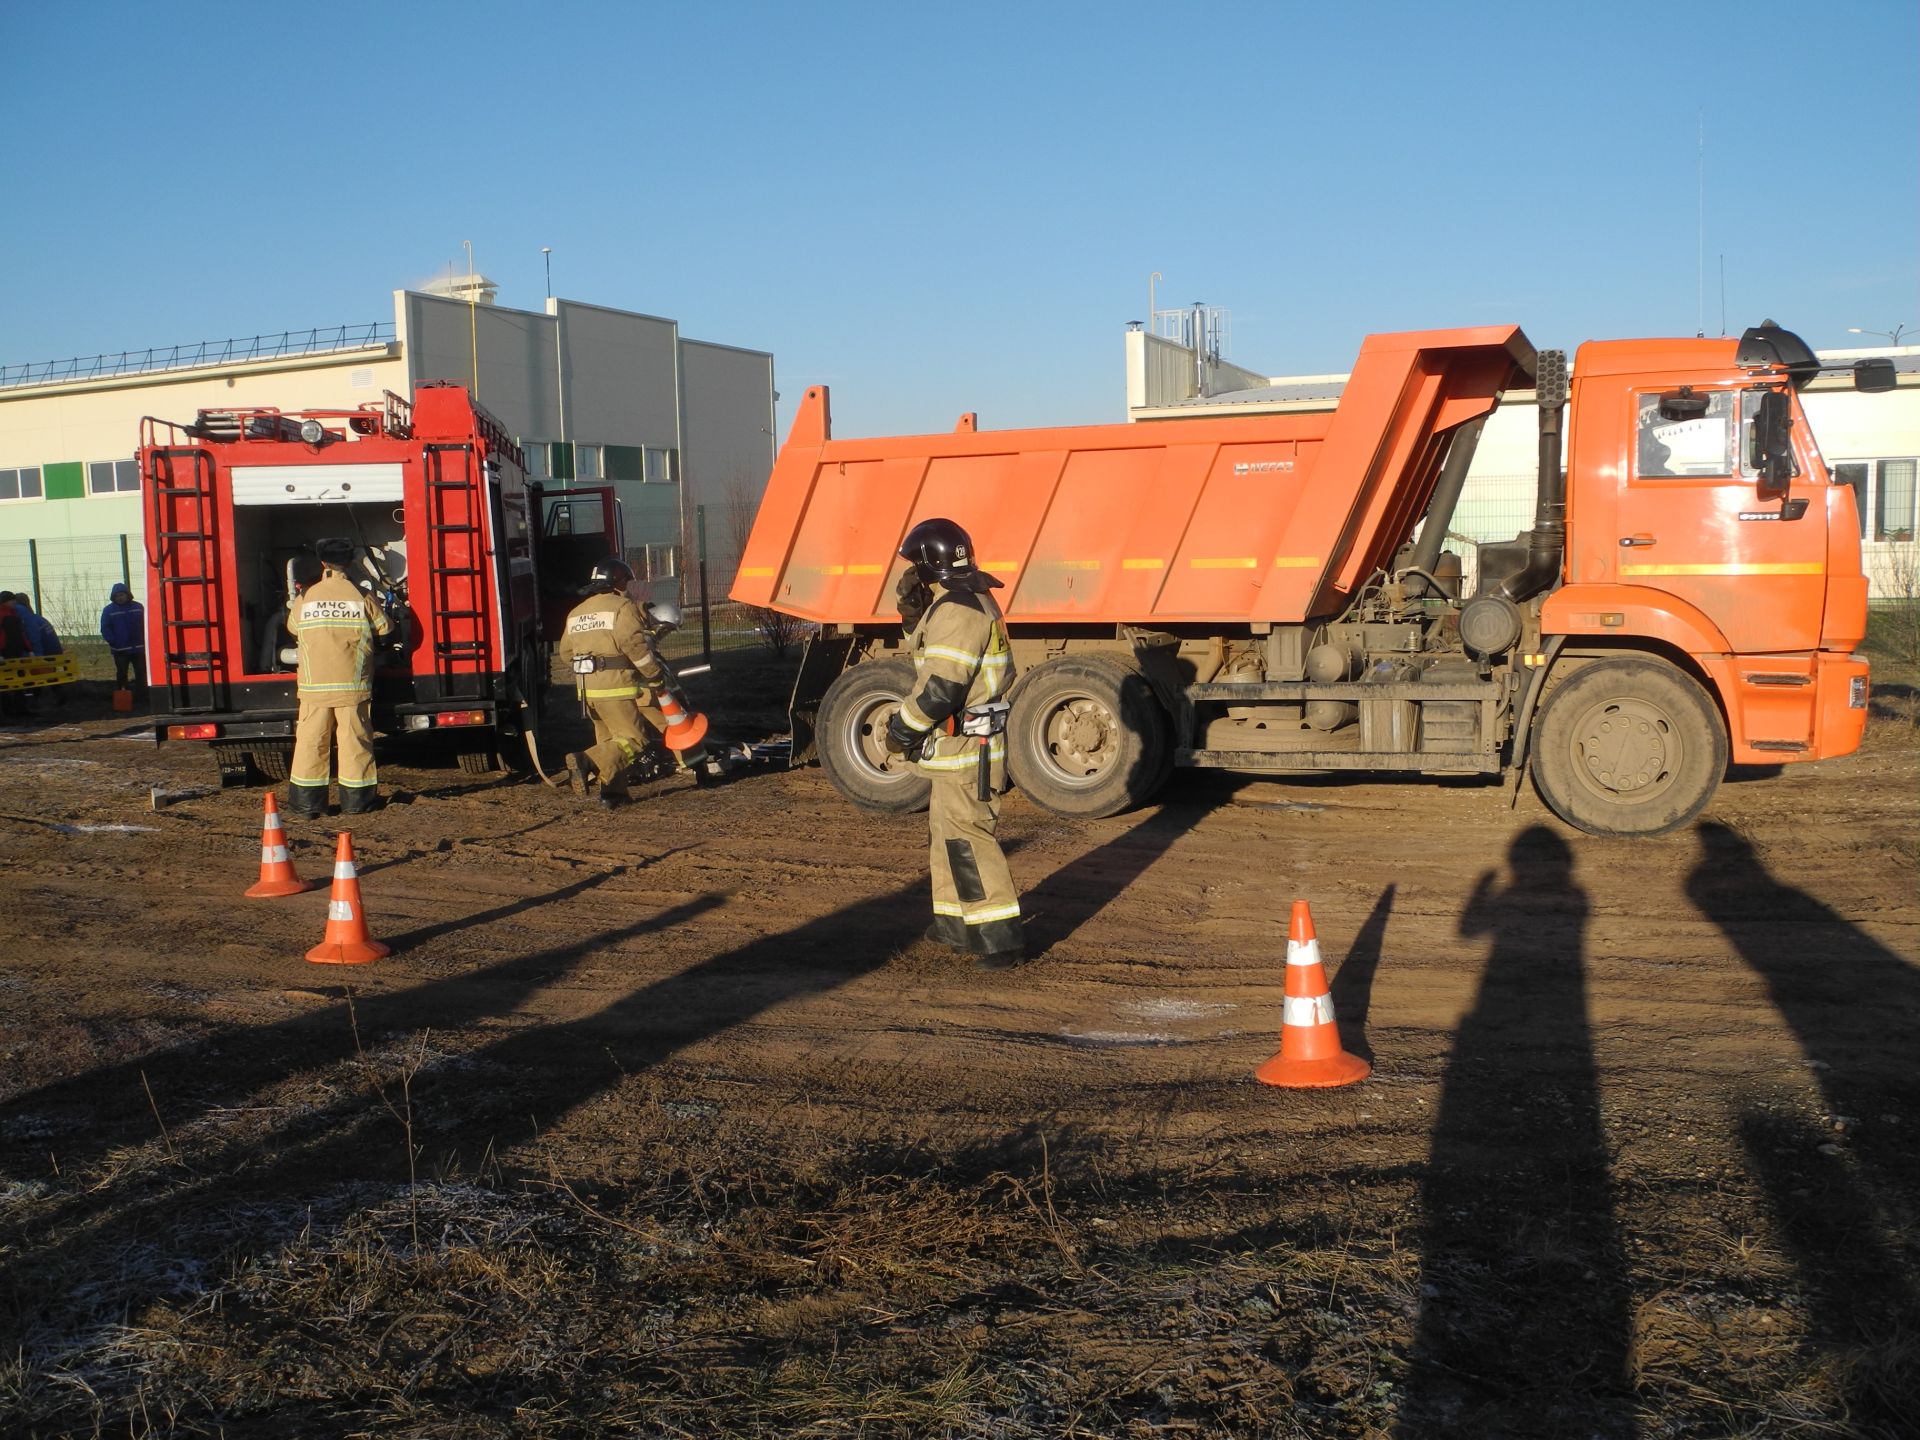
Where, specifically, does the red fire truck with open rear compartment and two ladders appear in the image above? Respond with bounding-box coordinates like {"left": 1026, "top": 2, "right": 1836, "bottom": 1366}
{"left": 140, "top": 380, "right": 622, "bottom": 783}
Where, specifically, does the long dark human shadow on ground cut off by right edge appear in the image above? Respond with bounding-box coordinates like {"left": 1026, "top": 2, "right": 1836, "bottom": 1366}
{"left": 1686, "top": 824, "right": 1920, "bottom": 1436}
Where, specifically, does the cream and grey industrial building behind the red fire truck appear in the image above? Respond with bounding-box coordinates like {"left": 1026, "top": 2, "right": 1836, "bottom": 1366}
{"left": 0, "top": 276, "right": 776, "bottom": 634}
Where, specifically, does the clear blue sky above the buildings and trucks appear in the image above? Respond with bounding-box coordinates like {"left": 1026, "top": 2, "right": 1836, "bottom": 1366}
{"left": 0, "top": 0, "right": 1920, "bottom": 434}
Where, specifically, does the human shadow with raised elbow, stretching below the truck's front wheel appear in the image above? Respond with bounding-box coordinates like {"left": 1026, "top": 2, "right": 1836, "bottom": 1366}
{"left": 1396, "top": 826, "right": 1636, "bottom": 1440}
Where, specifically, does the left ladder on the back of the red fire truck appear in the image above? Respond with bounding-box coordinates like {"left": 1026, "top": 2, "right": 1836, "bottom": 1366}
{"left": 146, "top": 447, "right": 227, "bottom": 714}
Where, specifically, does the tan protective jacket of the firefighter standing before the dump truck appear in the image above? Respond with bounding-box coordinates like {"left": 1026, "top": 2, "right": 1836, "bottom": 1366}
{"left": 900, "top": 588, "right": 1014, "bottom": 791}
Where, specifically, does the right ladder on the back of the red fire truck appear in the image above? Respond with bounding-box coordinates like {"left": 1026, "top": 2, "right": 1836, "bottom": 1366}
{"left": 426, "top": 445, "right": 493, "bottom": 699}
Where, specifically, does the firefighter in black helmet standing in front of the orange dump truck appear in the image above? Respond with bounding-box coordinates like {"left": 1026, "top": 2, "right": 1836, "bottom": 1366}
{"left": 885, "top": 520, "right": 1027, "bottom": 970}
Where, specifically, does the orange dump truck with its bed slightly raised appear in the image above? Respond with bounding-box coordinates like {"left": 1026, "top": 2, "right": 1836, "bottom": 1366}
{"left": 732, "top": 323, "right": 1893, "bottom": 835}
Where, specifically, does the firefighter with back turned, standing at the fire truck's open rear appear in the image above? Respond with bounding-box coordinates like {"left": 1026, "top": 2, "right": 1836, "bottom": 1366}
{"left": 286, "top": 540, "right": 394, "bottom": 820}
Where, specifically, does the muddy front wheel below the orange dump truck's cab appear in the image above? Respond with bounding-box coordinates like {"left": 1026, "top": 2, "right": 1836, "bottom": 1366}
{"left": 1532, "top": 659, "right": 1728, "bottom": 835}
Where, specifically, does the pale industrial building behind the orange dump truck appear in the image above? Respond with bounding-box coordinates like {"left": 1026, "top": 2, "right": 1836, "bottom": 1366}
{"left": 1125, "top": 305, "right": 1920, "bottom": 599}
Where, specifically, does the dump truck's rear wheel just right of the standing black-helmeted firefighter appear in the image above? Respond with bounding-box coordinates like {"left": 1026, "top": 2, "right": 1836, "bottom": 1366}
{"left": 1006, "top": 655, "right": 1169, "bottom": 820}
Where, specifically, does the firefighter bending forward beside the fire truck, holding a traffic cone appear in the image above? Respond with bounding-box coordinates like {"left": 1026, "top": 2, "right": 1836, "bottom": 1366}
{"left": 561, "top": 555, "right": 670, "bottom": 810}
